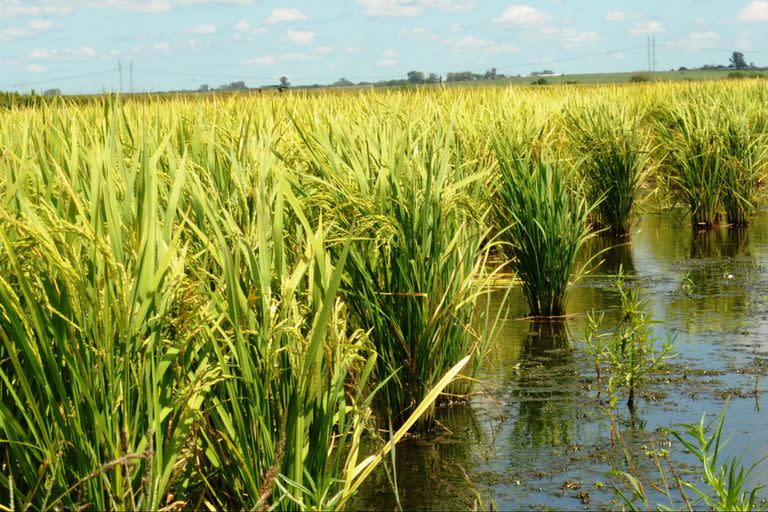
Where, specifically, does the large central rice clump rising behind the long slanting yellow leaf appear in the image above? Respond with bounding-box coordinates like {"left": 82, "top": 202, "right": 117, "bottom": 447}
{"left": 296, "top": 116, "right": 504, "bottom": 429}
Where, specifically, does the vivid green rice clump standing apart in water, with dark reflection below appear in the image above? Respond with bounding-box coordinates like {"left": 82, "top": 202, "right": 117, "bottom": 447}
{"left": 494, "top": 139, "right": 594, "bottom": 317}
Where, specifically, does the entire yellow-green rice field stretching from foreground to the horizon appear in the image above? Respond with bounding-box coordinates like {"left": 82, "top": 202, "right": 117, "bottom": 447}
{"left": 0, "top": 80, "right": 768, "bottom": 510}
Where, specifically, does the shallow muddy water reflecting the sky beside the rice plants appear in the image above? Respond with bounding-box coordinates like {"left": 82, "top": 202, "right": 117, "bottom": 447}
{"left": 353, "top": 212, "right": 768, "bottom": 510}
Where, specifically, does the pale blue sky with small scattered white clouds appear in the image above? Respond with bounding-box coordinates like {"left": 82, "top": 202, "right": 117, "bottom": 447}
{"left": 0, "top": 0, "right": 768, "bottom": 93}
